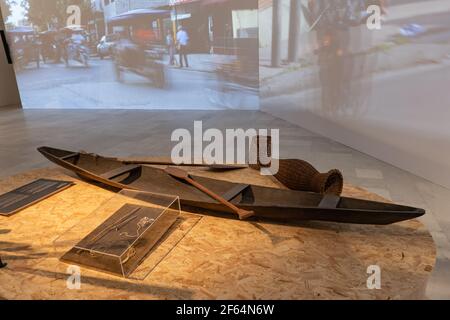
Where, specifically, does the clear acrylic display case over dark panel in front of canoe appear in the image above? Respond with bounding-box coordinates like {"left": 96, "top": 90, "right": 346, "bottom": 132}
{"left": 54, "top": 190, "right": 190, "bottom": 280}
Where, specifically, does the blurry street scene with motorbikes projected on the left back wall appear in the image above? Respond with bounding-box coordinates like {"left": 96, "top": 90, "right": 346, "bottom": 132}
{"left": 0, "top": 0, "right": 259, "bottom": 110}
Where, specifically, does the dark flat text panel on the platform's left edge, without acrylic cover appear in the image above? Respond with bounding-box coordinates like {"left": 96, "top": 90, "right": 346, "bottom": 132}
{"left": 0, "top": 179, "right": 74, "bottom": 217}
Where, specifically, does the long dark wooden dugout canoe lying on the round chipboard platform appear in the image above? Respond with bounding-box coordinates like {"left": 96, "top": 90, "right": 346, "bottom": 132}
{"left": 38, "top": 147, "right": 425, "bottom": 225}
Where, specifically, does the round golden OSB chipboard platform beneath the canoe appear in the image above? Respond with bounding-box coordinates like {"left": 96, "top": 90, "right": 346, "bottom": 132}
{"left": 0, "top": 168, "right": 436, "bottom": 299}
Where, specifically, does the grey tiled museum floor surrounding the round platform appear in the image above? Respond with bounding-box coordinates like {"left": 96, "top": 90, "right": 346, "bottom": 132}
{"left": 0, "top": 109, "right": 450, "bottom": 299}
